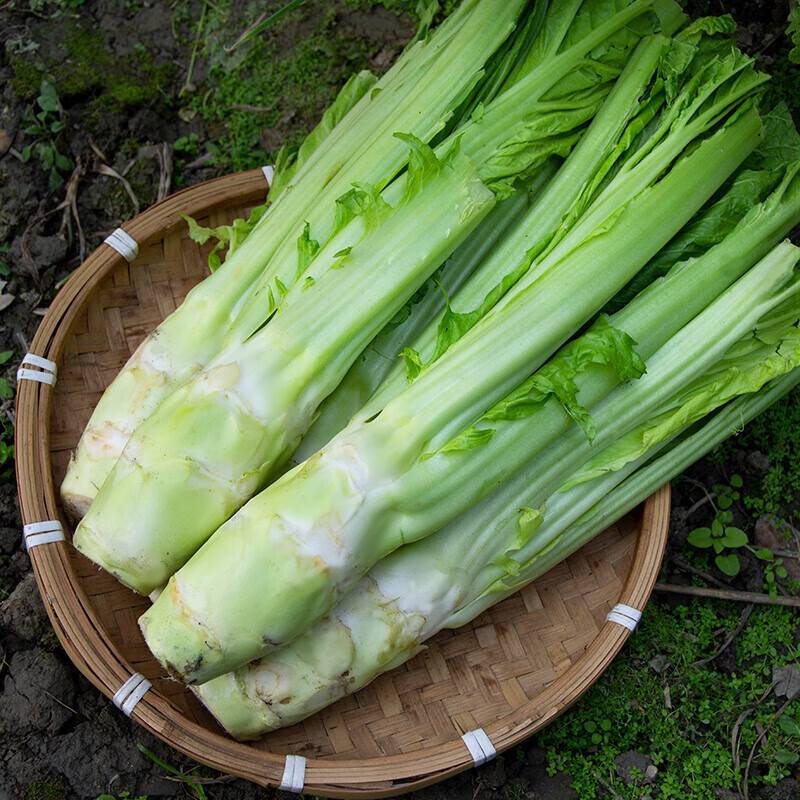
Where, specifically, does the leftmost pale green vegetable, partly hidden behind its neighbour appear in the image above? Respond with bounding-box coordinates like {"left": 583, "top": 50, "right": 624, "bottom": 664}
{"left": 61, "top": 0, "right": 540, "bottom": 518}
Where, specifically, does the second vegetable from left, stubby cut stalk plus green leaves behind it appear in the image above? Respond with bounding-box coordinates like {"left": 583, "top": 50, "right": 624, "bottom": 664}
{"left": 74, "top": 0, "right": 688, "bottom": 593}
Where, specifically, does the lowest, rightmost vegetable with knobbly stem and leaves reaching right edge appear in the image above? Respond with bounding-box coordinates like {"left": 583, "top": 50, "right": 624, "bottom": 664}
{"left": 189, "top": 123, "right": 800, "bottom": 738}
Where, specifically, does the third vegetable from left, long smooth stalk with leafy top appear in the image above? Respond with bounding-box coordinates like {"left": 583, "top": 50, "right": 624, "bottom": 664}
{"left": 141, "top": 43, "right": 761, "bottom": 682}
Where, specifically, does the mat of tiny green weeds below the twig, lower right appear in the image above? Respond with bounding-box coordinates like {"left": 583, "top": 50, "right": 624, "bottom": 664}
{"left": 535, "top": 601, "right": 800, "bottom": 800}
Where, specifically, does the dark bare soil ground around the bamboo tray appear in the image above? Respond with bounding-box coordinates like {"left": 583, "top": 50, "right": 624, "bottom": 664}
{"left": 0, "top": 0, "right": 800, "bottom": 800}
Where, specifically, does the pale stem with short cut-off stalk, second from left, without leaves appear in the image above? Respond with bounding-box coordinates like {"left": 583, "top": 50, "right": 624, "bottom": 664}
{"left": 73, "top": 144, "right": 494, "bottom": 594}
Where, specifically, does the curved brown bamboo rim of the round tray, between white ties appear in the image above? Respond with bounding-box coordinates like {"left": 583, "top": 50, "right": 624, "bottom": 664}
{"left": 15, "top": 169, "right": 670, "bottom": 798}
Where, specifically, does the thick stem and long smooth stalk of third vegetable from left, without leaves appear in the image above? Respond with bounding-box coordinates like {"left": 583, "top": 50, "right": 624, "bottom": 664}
{"left": 140, "top": 112, "right": 761, "bottom": 683}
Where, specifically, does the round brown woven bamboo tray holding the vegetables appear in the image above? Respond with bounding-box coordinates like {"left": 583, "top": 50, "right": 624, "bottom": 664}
{"left": 16, "top": 170, "right": 670, "bottom": 798}
